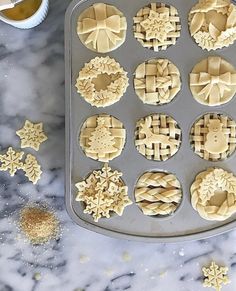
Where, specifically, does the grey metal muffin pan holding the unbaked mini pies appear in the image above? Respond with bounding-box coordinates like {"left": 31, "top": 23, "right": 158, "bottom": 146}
{"left": 65, "top": 0, "right": 236, "bottom": 242}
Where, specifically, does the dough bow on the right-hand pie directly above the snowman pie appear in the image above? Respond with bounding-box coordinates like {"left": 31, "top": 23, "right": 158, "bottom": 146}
{"left": 190, "top": 57, "right": 236, "bottom": 104}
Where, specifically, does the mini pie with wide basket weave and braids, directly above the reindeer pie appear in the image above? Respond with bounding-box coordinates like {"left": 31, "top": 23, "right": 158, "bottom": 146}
{"left": 134, "top": 59, "right": 181, "bottom": 105}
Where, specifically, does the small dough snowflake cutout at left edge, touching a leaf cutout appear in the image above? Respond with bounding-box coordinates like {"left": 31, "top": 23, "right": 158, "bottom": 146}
{"left": 0, "top": 147, "right": 24, "bottom": 176}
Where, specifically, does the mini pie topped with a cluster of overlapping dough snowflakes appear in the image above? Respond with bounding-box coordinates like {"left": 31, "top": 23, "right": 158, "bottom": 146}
{"left": 75, "top": 164, "right": 132, "bottom": 222}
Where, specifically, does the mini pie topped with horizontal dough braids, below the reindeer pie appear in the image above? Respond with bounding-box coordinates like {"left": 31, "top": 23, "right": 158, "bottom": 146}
{"left": 134, "top": 172, "right": 182, "bottom": 216}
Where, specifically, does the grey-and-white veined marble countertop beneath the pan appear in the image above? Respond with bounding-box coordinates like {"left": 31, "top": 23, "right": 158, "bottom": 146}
{"left": 0, "top": 0, "right": 236, "bottom": 291}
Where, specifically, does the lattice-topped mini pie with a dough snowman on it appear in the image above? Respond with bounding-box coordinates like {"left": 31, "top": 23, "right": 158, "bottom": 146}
{"left": 190, "top": 113, "right": 236, "bottom": 161}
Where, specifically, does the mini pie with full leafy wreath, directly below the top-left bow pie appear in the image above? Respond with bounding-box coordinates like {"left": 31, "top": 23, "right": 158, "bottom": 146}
{"left": 75, "top": 57, "right": 129, "bottom": 107}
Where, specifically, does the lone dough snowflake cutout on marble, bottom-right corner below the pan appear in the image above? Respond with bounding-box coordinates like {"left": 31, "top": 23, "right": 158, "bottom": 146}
{"left": 202, "top": 262, "right": 230, "bottom": 291}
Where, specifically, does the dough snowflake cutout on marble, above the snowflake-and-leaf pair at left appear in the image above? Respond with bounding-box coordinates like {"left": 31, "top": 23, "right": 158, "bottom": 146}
{"left": 16, "top": 120, "right": 48, "bottom": 151}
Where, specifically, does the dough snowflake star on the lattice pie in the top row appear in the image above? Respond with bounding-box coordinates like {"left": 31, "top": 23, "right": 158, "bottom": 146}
{"left": 140, "top": 10, "right": 175, "bottom": 42}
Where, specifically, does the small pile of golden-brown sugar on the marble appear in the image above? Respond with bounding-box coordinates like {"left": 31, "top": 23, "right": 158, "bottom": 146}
{"left": 19, "top": 206, "right": 59, "bottom": 244}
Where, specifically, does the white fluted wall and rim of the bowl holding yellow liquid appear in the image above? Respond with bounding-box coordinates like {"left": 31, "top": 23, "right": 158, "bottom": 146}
{"left": 0, "top": 0, "right": 49, "bottom": 29}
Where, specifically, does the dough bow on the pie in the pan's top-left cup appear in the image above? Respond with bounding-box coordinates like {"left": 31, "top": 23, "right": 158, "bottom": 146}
{"left": 77, "top": 3, "right": 127, "bottom": 52}
